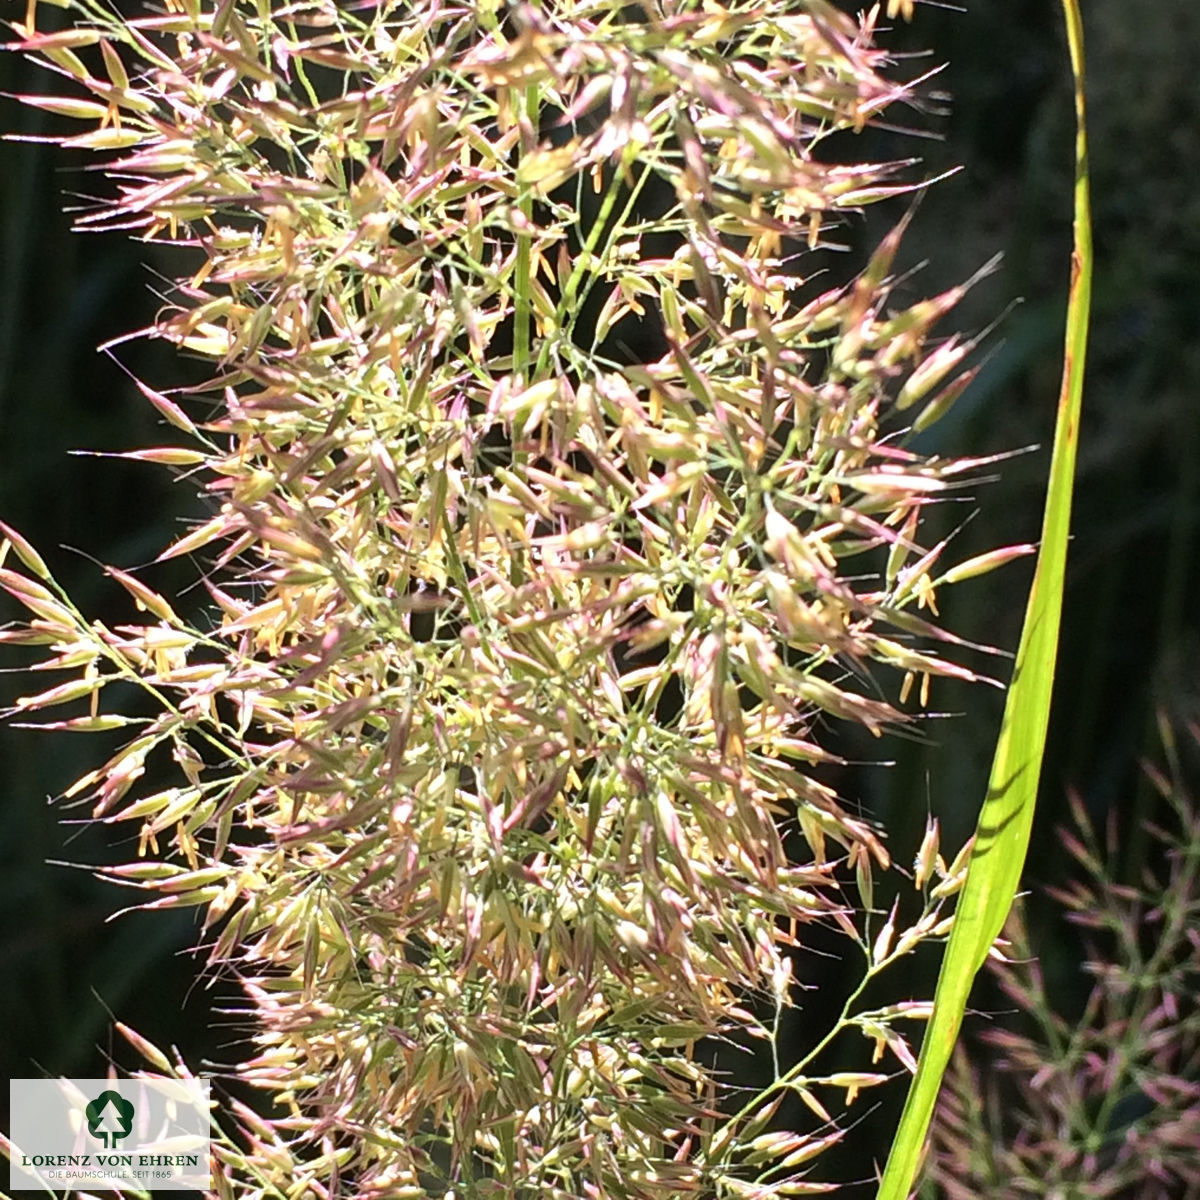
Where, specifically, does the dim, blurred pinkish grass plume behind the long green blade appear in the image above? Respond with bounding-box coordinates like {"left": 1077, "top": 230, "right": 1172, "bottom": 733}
{"left": 930, "top": 722, "right": 1200, "bottom": 1200}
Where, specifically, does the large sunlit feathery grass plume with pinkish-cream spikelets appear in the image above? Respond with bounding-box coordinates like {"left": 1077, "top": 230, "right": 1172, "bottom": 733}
{"left": 0, "top": 0, "right": 1027, "bottom": 1198}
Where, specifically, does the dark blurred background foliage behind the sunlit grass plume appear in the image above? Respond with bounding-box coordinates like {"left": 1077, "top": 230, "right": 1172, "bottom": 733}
{"left": 0, "top": 0, "right": 1200, "bottom": 1178}
